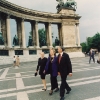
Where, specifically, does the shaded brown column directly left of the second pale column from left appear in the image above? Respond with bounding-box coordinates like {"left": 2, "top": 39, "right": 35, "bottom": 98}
{"left": 16, "top": 19, "right": 22, "bottom": 47}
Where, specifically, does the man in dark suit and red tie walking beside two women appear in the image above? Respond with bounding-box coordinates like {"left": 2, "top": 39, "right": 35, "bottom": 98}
{"left": 58, "top": 47, "right": 72, "bottom": 100}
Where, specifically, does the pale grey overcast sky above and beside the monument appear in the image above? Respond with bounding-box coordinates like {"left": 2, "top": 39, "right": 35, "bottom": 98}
{"left": 8, "top": 0, "right": 100, "bottom": 42}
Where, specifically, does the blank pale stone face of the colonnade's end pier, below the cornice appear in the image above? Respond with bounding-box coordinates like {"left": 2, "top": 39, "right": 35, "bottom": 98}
{"left": 62, "top": 21, "right": 76, "bottom": 47}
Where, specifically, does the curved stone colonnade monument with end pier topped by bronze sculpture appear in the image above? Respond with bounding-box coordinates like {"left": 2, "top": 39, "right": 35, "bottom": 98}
{"left": 0, "top": 0, "right": 84, "bottom": 63}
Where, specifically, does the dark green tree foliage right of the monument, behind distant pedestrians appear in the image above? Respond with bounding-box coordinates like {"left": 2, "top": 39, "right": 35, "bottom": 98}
{"left": 81, "top": 32, "right": 100, "bottom": 53}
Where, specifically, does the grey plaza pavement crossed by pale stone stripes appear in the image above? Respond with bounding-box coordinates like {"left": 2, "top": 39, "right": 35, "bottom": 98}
{"left": 0, "top": 57, "right": 100, "bottom": 100}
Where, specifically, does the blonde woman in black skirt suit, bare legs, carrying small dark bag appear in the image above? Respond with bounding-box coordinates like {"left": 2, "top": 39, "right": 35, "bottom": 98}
{"left": 35, "top": 52, "right": 47, "bottom": 91}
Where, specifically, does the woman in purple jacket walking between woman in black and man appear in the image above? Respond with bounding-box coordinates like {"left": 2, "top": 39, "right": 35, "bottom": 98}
{"left": 44, "top": 49, "right": 59, "bottom": 95}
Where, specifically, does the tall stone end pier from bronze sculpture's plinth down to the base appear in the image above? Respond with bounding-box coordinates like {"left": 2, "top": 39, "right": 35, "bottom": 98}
{"left": 58, "top": 8, "right": 76, "bottom": 47}
